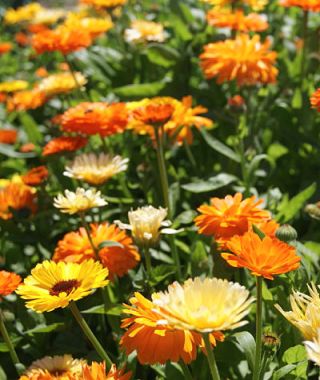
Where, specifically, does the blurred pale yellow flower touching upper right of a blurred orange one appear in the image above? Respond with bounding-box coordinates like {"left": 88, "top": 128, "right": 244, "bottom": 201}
{"left": 37, "top": 72, "right": 87, "bottom": 97}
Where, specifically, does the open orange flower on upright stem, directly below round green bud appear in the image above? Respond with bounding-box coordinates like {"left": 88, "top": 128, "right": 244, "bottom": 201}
{"left": 221, "top": 231, "right": 301, "bottom": 280}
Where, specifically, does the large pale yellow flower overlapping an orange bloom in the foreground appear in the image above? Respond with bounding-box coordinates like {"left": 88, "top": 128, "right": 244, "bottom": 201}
{"left": 152, "top": 277, "right": 254, "bottom": 333}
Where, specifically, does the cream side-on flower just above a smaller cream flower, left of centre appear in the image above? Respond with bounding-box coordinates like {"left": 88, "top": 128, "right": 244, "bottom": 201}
{"left": 63, "top": 153, "right": 129, "bottom": 186}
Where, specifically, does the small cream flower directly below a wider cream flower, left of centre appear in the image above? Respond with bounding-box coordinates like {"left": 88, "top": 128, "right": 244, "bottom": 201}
{"left": 53, "top": 187, "right": 108, "bottom": 215}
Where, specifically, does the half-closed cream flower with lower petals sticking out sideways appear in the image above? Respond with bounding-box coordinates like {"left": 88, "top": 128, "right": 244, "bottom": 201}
{"left": 115, "top": 206, "right": 179, "bottom": 247}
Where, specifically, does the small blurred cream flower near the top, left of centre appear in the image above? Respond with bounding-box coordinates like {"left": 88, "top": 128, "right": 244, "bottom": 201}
{"left": 124, "top": 20, "right": 166, "bottom": 43}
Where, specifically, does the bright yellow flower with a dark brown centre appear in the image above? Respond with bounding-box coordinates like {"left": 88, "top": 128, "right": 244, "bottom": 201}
{"left": 16, "top": 259, "right": 109, "bottom": 313}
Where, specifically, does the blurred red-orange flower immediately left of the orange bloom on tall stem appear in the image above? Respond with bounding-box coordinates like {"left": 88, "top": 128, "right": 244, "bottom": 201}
{"left": 62, "top": 102, "right": 128, "bottom": 136}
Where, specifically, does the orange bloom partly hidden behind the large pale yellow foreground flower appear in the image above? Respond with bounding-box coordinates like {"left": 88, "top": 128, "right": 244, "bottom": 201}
{"left": 120, "top": 293, "right": 224, "bottom": 364}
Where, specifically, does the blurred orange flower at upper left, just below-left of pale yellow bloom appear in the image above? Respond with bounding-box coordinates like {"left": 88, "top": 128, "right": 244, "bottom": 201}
{"left": 7, "top": 88, "right": 47, "bottom": 112}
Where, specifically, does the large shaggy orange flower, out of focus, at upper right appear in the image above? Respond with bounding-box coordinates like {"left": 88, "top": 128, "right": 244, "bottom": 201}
{"left": 200, "top": 34, "right": 278, "bottom": 86}
